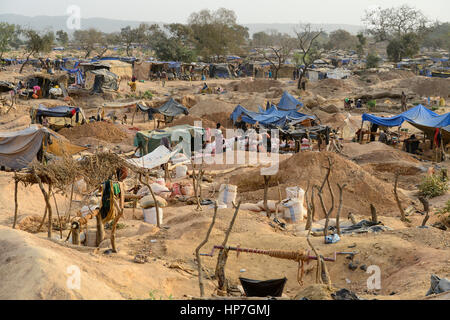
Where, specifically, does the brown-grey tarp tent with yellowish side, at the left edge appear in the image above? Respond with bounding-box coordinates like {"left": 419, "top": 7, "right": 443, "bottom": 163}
{"left": 0, "top": 125, "right": 86, "bottom": 170}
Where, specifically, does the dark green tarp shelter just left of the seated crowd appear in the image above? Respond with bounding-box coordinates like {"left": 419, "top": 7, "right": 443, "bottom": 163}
{"left": 134, "top": 125, "right": 205, "bottom": 155}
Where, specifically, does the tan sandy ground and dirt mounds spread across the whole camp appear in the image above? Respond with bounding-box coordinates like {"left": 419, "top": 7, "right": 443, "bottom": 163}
{"left": 0, "top": 65, "right": 450, "bottom": 300}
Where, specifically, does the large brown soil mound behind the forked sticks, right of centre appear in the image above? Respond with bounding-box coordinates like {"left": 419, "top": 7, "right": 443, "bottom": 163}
{"left": 230, "top": 152, "right": 411, "bottom": 217}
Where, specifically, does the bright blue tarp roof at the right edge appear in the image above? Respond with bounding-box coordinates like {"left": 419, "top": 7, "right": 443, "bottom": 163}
{"left": 362, "top": 104, "right": 450, "bottom": 130}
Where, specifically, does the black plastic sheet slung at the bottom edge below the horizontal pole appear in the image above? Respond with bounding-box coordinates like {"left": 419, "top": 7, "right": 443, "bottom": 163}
{"left": 239, "top": 278, "right": 287, "bottom": 298}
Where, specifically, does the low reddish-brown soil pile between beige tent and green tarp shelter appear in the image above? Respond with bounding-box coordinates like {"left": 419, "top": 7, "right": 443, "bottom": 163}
{"left": 59, "top": 122, "right": 128, "bottom": 143}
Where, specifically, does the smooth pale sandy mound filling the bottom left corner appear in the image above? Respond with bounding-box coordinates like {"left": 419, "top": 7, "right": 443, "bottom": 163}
{"left": 0, "top": 227, "right": 123, "bottom": 300}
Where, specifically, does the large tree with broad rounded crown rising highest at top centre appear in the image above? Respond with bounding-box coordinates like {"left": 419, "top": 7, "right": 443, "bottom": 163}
{"left": 188, "top": 8, "right": 249, "bottom": 60}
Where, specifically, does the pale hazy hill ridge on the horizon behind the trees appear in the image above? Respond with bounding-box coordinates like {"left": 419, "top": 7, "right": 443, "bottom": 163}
{"left": 0, "top": 14, "right": 363, "bottom": 35}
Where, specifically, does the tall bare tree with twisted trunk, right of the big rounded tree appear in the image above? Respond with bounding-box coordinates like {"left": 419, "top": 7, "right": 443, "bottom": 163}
{"left": 294, "top": 24, "right": 322, "bottom": 89}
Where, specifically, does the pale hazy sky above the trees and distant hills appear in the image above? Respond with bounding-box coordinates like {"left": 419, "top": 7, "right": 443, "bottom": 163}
{"left": 0, "top": 0, "right": 450, "bottom": 25}
